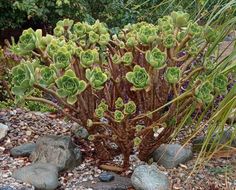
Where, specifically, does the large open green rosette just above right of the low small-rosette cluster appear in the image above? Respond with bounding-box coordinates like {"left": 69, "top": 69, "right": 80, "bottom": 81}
{"left": 126, "top": 65, "right": 150, "bottom": 90}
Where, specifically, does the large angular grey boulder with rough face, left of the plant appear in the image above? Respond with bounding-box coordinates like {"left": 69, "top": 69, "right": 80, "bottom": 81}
{"left": 30, "top": 135, "right": 82, "bottom": 171}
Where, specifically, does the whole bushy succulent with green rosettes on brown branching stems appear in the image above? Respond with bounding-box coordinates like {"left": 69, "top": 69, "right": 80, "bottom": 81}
{"left": 8, "top": 12, "right": 228, "bottom": 168}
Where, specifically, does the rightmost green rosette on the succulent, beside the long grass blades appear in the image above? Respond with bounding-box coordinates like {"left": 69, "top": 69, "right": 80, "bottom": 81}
{"left": 213, "top": 74, "right": 228, "bottom": 93}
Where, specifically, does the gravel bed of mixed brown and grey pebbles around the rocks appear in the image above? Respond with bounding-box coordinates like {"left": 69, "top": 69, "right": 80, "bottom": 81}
{"left": 0, "top": 109, "right": 236, "bottom": 190}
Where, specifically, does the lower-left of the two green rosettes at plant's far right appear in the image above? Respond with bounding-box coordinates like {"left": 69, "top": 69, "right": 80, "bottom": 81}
{"left": 195, "top": 81, "right": 214, "bottom": 103}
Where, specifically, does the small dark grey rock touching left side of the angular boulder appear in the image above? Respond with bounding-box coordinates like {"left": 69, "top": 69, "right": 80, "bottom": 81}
{"left": 10, "top": 143, "right": 36, "bottom": 157}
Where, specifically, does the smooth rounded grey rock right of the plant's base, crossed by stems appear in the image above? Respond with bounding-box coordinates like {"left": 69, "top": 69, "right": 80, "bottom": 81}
{"left": 153, "top": 144, "right": 193, "bottom": 168}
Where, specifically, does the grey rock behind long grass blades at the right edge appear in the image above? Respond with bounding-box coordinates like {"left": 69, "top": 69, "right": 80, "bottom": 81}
{"left": 192, "top": 128, "right": 236, "bottom": 152}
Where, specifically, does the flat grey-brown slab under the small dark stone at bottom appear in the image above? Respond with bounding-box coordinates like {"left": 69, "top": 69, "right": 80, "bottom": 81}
{"left": 78, "top": 172, "right": 132, "bottom": 190}
